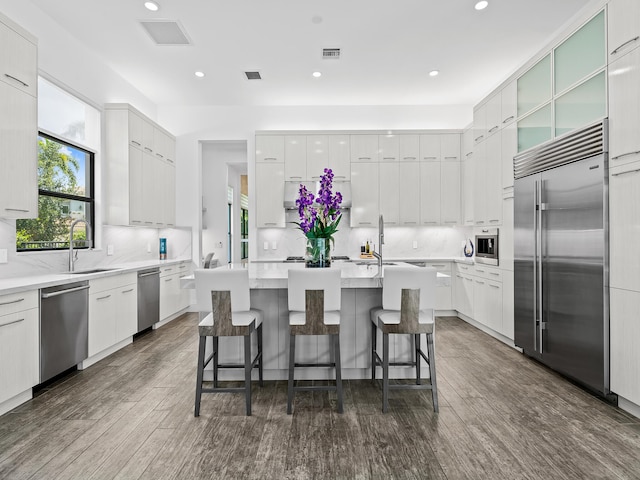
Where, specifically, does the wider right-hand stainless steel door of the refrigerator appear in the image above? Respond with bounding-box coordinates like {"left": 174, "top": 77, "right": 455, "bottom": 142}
{"left": 540, "top": 155, "right": 608, "bottom": 392}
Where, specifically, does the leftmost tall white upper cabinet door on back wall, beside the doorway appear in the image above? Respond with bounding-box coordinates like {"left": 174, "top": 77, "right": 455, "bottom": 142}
{"left": 256, "top": 163, "right": 285, "bottom": 228}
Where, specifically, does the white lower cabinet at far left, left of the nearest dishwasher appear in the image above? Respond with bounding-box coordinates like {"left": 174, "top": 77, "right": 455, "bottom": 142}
{"left": 0, "top": 290, "right": 40, "bottom": 406}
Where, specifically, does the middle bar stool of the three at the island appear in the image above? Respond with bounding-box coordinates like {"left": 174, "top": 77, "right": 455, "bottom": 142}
{"left": 287, "top": 268, "right": 343, "bottom": 415}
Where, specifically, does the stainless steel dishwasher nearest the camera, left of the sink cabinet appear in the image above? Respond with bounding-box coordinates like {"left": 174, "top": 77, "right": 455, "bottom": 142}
{"left": 40, "top": 282, "right": 89, "bottom": 383}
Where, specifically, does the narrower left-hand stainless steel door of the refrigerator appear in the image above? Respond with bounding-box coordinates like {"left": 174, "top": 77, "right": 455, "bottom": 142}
{"left": 513, "top": 174, "right": 540, "bottom": 357}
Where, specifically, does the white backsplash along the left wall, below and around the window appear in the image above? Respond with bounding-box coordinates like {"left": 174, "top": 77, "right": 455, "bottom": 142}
{"left": 0, "top": 219, "right": 191, "bottom": 278}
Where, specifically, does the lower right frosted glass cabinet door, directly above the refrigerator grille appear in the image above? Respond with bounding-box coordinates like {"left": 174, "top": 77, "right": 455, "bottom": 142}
{"left": 555, "top": 72, "right": 604, "bottom": 137}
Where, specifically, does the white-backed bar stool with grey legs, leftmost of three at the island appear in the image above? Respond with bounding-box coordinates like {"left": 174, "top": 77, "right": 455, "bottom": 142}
{"left": 194, "top": 269, "right": 262, "bottom": 417}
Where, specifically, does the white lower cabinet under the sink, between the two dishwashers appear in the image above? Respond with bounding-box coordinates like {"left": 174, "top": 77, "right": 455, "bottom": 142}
{"left": 89, "top": 273, "right": 138, "bottom": 357}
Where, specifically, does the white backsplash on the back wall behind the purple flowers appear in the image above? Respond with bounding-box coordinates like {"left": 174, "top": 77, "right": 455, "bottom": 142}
{"left": 257, "top": 210, "right": 472, "bottom": 260}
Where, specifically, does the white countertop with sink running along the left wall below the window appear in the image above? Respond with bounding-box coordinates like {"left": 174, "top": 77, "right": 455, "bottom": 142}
{"left": 0, "top": 258, "right": 191, "bottom": 295}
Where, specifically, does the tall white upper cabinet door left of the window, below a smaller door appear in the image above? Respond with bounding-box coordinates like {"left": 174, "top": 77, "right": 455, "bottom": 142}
{"left": 0, "top": 81, "right": 38, "bottom": 218}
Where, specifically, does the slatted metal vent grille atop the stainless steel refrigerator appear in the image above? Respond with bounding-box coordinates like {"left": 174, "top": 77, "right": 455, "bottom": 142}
{"left": 513, "top": 119, "right": 608, "bottom": 178}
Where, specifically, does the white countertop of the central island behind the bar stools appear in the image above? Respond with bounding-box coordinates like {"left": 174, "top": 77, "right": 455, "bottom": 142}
{"left": 180, "top": 260, "right": 451, "bottom": 289}
